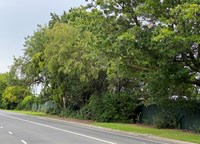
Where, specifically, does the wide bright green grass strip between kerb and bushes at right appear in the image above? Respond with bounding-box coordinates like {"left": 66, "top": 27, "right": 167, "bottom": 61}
{"left": 93, "top": 123, "right": 200, "bottom": 144}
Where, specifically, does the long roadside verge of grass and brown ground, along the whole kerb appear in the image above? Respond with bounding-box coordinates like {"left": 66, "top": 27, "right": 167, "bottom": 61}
{"left": 5, "top": 110, "right": 200, "bottom": 143}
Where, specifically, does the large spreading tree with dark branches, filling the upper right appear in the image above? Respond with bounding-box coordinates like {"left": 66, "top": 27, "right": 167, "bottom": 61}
{"left": 87, "top": 0, "right": 199, "bottom": 98}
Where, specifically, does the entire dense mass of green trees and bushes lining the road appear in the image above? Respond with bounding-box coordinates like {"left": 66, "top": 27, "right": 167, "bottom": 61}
{"left": 0, "top": 0, "right": 200, "bottom": 140}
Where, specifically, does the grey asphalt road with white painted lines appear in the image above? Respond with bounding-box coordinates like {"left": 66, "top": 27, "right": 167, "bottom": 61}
{"left": 0, "top": 110, "right": 194, "bottom": 144}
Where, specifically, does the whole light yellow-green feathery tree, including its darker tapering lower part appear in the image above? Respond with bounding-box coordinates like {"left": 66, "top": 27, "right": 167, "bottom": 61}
{"left": 45, "top": 23, "right": 99, "bottom": 108}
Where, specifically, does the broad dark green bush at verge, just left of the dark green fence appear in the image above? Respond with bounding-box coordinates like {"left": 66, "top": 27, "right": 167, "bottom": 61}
{"left": 81, "top": 93, "right": 137, "bottom": 122}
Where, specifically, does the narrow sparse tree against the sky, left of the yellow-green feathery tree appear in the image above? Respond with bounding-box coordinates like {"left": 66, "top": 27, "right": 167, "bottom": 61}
{"left": 21, "top": 25, "right": 48, "bottom": 86}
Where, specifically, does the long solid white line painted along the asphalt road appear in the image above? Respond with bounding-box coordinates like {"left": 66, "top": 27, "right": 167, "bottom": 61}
{"left": 0, "top": 113, "right": 117, "bottom": 144}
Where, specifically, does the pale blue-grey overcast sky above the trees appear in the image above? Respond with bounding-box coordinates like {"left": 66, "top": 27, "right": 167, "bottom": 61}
{"left": 0, "top": 0, "right": 85, "bottom": 73}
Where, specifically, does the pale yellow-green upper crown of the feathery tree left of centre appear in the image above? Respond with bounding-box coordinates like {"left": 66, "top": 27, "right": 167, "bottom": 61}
{"left": 45, "top": 23, "right": 99, "bottom": 81}
